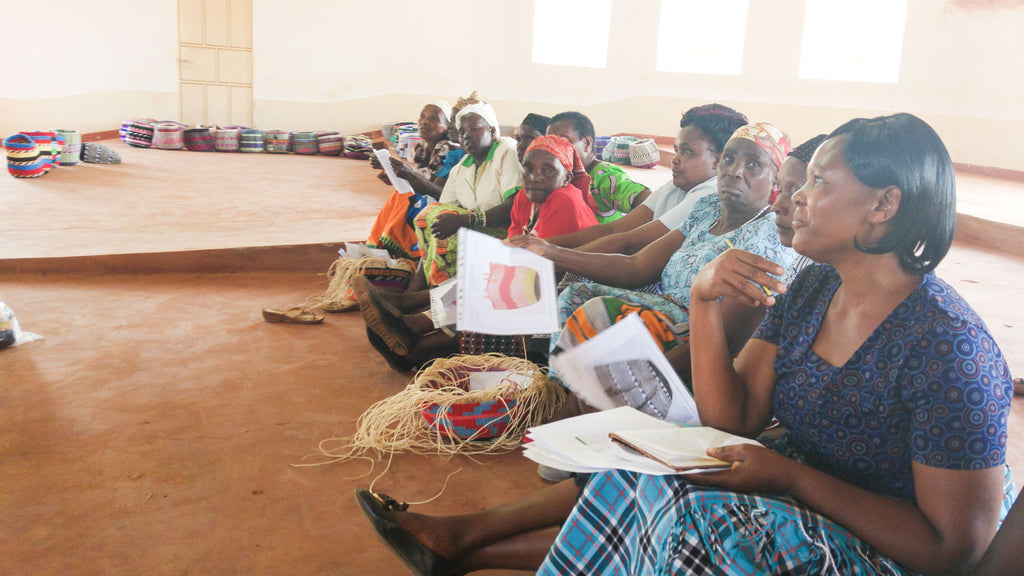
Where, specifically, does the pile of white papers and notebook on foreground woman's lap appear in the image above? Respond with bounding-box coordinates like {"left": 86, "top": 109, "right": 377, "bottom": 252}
{"left": 523, "top": 406, "right": 759, "bottom": 476}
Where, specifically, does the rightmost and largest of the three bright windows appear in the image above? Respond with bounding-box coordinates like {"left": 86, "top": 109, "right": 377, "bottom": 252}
{"left": 800, "top": 0, "right": 906, "bottom": 83}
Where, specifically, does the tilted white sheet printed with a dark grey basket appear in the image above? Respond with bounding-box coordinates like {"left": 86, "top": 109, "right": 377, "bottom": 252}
{"left": 551, "top": 314, "right": 700, "bottom": 425}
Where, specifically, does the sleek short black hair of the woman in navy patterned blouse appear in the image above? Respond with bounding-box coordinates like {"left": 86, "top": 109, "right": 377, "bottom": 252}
{"left": 828, "top": 113, "right": 956, "bottom": 275}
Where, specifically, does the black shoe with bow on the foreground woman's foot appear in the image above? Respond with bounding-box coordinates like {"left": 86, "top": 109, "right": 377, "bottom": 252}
{"left": 355, "top": 488, "right": 455, "bottom": 576}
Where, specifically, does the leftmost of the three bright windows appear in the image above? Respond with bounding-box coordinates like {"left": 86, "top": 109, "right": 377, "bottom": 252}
{"left": 534, "top": 0, "right": 611, "bottom": 68}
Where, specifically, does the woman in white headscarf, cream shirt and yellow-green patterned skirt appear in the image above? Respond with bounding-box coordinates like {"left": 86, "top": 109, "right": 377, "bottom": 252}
{"left": 411, "top": 102, "right": 522, "bottom": 288}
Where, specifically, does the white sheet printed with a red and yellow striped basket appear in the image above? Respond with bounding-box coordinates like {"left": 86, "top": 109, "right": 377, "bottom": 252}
{"left": 456, "top": 228, "right": 558, "bottom": 334}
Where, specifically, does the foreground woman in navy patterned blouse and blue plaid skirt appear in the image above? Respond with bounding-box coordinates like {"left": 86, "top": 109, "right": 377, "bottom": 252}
{"left": 356, "top": 114, "right": 1020, "bottom": 576}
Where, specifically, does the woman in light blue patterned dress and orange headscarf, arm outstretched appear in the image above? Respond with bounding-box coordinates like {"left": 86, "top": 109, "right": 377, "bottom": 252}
{"left": 506, "top": 123, "right": 793, "bottom": 362}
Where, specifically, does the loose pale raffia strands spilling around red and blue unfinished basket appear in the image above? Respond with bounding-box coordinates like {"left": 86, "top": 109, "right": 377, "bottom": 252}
{"left": 319, "top": 355, "right": 565, "bottom": 461}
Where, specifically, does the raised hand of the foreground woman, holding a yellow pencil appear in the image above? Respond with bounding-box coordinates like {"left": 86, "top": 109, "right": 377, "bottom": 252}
{"left": 690, "top": 249, "right": 785, "bottom": 306}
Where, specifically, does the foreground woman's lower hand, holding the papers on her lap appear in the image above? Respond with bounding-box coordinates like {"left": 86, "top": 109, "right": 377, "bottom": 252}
{"left": 687, "top": 444, "right": 800, "bottom": 494}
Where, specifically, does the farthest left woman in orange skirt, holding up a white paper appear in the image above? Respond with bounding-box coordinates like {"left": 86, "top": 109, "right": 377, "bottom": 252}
{"left": 367, "top": 100, "right": 459, "bottom": 259}
